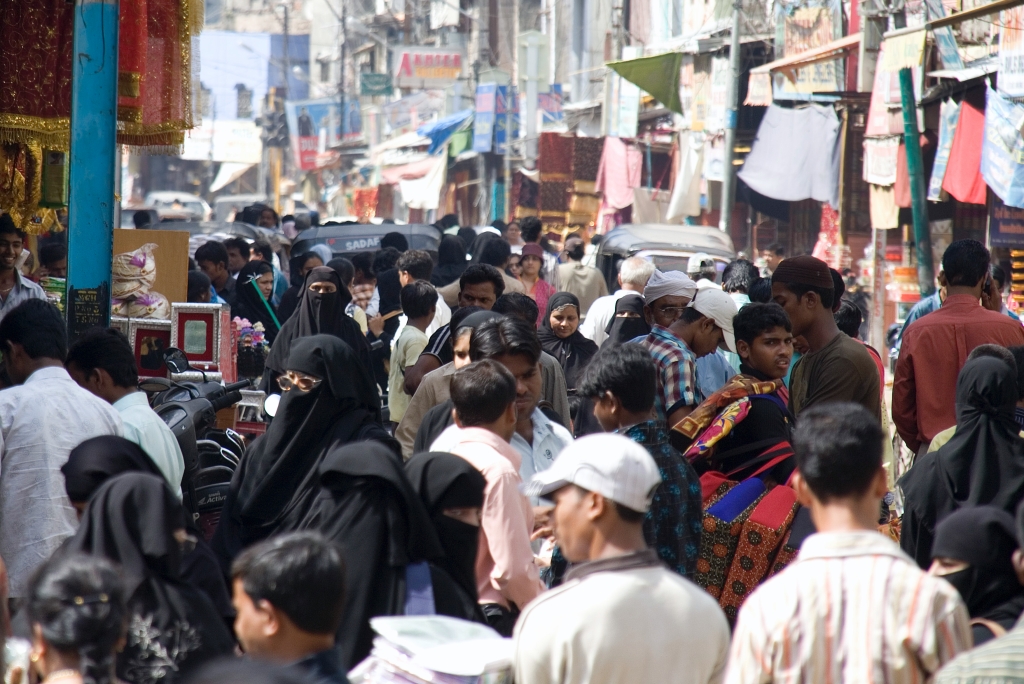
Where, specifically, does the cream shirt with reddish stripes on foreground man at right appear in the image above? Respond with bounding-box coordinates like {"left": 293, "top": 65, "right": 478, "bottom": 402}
{"left": 725, "top": 530, "right": 972, "bottom": 684}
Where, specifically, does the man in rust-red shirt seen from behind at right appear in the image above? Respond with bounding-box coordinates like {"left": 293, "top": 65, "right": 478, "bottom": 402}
{"left": 893, "top": 240, "right": 1024, "bottom": 453}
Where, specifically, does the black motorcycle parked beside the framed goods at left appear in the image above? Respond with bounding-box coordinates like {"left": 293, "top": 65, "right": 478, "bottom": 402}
{"left": 139, "top": 348, "right": 249, "bottom": 541}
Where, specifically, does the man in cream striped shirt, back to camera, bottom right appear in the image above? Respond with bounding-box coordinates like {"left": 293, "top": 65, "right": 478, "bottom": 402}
{"left": 725, "top": 403, "right": 972, "bottom": 684}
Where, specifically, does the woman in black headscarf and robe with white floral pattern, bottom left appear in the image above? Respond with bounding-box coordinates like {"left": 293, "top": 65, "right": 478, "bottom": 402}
{"left": 63, "top": 472, "right": 234, "bottom": 684}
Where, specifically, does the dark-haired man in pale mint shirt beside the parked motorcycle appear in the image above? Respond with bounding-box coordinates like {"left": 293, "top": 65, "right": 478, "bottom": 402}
{"left": 65, "top": 328, "right": 185, "bottom": 491}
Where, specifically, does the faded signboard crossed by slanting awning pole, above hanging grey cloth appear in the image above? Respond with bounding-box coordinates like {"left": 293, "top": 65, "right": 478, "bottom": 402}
{"left": 774, "top": 0, "right": 843, "bottom": 99}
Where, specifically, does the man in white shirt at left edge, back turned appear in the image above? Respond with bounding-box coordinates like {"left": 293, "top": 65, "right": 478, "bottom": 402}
{"left": 0, "top": 299, "right": 123, "bottom": 599}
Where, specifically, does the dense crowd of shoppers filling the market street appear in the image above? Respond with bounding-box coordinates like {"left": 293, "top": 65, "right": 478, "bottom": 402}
{"left": 9, "top": 205, "right": 1024, "bottom": 684}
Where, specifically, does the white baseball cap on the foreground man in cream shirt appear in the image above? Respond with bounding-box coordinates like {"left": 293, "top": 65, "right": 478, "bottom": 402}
{"left": 523, "top": 433, "right": 662, "bottom": 513}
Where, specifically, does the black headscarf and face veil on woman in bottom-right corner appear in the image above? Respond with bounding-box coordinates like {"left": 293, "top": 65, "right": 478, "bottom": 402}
{"left": 932, "top": 506, "right": 1024, "bottom": 645}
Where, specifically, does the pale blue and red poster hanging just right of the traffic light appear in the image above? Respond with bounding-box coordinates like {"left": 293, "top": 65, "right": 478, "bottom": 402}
{"left": 285, "top": 97, "right": 362, "bottom": 171}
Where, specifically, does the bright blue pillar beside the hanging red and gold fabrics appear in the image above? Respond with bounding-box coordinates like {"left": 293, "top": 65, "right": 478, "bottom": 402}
{"left": 67, "top": 0, "right": 118, "bottom": 339}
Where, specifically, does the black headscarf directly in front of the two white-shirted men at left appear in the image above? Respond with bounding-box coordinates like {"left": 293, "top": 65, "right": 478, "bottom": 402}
{"left": 60, "top": 435, "right": 164, "bottom": 504}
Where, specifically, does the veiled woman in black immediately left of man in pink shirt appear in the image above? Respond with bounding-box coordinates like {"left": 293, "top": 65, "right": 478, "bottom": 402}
{"left": 406, "top": 452, "right": 487, "bottom": 624}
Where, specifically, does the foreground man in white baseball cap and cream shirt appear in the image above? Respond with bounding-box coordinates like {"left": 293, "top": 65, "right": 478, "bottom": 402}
{"left": 513, "top": 434, "right": 729, "bottom": 684}
